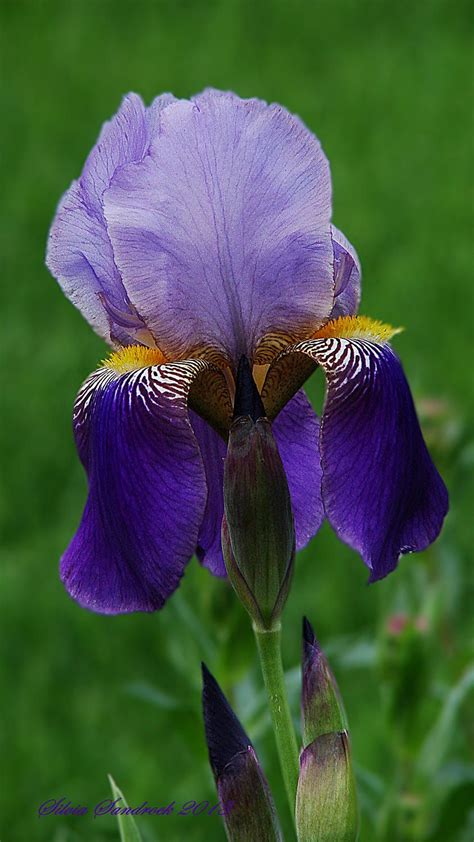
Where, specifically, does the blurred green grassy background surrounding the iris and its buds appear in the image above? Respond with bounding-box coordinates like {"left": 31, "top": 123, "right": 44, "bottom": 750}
{"left": 0, "top": 0, "right": 474, "bottom": 842}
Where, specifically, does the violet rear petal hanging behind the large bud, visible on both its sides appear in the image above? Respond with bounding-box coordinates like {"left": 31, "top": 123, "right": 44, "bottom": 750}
{"left": 191, "top": 392, "right": 324, "bottom": 576}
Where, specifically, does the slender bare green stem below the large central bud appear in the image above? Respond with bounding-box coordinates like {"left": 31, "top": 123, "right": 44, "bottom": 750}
{"left": 254, "top": 626, "right": 299, "bottom": 820}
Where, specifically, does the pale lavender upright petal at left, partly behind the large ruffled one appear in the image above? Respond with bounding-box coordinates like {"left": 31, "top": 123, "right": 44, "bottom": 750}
{"left": 46, "top": 94, "right": 173, "bottom": 345}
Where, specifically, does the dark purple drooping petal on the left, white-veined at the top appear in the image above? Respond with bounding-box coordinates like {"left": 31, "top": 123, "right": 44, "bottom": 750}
{"left": 61, "top": 348, "right": 218, "bottom": 614}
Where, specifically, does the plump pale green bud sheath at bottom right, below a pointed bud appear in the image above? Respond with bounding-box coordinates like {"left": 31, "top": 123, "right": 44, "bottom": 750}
{"left": 296, "top": 731, "right": 358, "bottom": 842}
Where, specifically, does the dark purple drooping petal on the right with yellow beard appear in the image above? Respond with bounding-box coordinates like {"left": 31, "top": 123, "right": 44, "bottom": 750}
{"left": 269, "top": 317, "right": 448, "bottom": 581}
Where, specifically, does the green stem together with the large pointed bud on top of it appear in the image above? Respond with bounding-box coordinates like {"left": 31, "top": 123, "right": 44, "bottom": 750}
{"left": 222, "top": 357, "right": 299, "bottom": 816}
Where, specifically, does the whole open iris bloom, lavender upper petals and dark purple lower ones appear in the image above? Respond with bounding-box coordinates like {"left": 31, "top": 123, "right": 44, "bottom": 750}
{"left": 47, "top": 90, "right": 447, "bottom": 613}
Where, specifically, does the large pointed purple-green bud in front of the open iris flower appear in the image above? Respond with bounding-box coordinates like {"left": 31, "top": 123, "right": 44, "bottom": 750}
{"left": 222, "top": 357, "right": 295, "bottom": 629}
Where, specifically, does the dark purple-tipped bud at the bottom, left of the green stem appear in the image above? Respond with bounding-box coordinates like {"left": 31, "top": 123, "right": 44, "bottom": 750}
{"left": 202, "top": 664, "right": 282, "bottom": 842}
